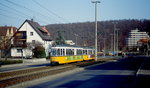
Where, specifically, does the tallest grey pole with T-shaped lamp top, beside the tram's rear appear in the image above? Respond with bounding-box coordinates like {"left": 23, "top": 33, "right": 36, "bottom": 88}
{"left": 92, "top": 1, "right": 100, "bottom": 61}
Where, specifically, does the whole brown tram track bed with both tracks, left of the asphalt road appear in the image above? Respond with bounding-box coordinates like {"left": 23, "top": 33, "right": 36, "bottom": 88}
{"left": 0, "top": 60, "right": 113, "bottom": 88}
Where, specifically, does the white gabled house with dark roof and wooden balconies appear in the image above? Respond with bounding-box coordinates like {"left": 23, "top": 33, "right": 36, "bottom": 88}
{"left": 11, "top": 20, "right": 51, "bottom": 57}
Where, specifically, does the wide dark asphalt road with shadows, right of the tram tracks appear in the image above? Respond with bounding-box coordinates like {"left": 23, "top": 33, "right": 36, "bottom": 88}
{"left": 28, "top": 57, "right": 150, "bottom": 88}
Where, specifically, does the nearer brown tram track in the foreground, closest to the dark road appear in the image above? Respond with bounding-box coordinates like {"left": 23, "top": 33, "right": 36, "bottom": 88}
{"left": 0, "top": 66, "right": 75, "bottom": 88}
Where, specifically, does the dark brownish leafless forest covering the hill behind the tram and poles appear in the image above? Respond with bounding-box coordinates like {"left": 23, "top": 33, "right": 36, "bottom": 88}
{"left": 46, "top": 19, "right": 150, "bottom": 50}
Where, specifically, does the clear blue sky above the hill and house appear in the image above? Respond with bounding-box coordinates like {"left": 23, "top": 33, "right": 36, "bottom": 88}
{"left": 0, "top": 0, "right": 150, "bottom": 27}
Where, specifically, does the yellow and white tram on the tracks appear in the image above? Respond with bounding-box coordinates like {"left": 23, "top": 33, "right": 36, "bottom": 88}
{"left": 50, "top": 45, "right": 95, "bottom": 64}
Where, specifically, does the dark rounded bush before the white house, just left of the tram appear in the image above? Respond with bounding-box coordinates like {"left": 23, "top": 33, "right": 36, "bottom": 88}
{"left": 33, "top": 46, "right": 46, "bottom": 58}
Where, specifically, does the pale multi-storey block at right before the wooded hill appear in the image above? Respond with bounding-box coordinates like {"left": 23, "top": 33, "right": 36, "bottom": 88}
{"left": 126, "top": 29, "right": 149, "bottom": 51}
